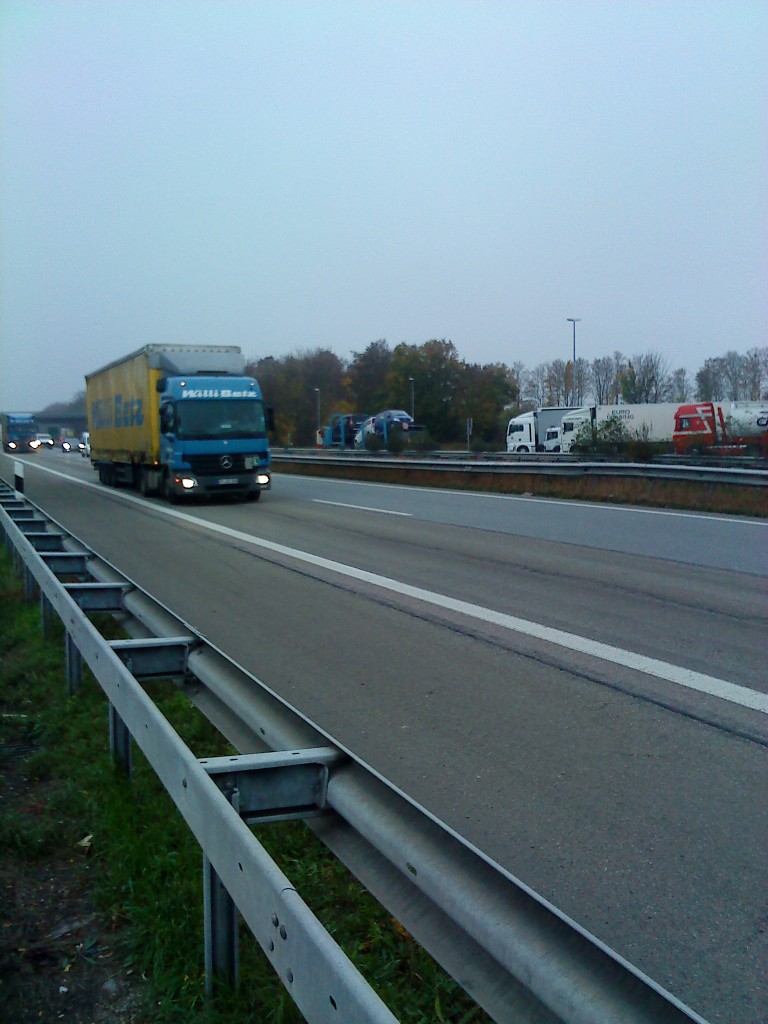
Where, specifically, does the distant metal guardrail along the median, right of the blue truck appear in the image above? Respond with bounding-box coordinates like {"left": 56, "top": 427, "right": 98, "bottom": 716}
{"left": 272, "top": 449, "right": 768, "bottom": 487}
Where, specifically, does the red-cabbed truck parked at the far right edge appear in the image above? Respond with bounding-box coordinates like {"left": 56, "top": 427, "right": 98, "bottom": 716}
{"left": 674, "top": 401, "right": 768, "bottom": 459}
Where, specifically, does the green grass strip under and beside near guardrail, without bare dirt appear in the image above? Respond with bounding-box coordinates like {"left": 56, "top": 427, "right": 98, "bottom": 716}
{"left": 0, "top": 551, "right": 489, "bottom": 1024}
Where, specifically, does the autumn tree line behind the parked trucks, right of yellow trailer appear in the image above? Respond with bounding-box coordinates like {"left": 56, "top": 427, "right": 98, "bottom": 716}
{"left": 246, "top": 339, "right": 768, "bottom": 445}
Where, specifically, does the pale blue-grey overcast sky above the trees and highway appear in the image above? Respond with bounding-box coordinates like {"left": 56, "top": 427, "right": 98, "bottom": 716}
{"left": 0, "top": 0, "right": 768, "bottom": 410}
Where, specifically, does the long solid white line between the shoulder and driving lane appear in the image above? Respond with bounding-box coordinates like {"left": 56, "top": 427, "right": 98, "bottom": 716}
{"left": 13, "top": 466, "right": 768, "bottom": 715}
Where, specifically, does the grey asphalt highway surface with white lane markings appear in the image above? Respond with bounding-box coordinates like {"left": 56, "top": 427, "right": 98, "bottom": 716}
{"left": 6, "top": 452, "right": 768, "bottom": 1024}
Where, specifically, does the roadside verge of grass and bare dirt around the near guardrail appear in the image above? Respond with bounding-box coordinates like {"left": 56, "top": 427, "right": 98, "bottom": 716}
{"left": 0, "top": 552, "right": 488, "bottom": 1024}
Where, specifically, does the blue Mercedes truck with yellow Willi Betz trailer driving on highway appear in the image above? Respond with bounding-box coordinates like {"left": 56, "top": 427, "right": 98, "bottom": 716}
{"left": 85, "top": 345, "right": 273, "bottom": 502}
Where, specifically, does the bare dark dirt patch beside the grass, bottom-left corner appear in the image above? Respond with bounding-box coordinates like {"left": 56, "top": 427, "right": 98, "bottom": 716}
{"left": 0, "top": 737, "right": 145, "bottom": 1024}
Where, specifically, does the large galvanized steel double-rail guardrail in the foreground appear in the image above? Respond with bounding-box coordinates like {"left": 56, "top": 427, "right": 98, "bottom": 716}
{"left": 0, "top": 481, "right": 706, "bottom": 1024}
